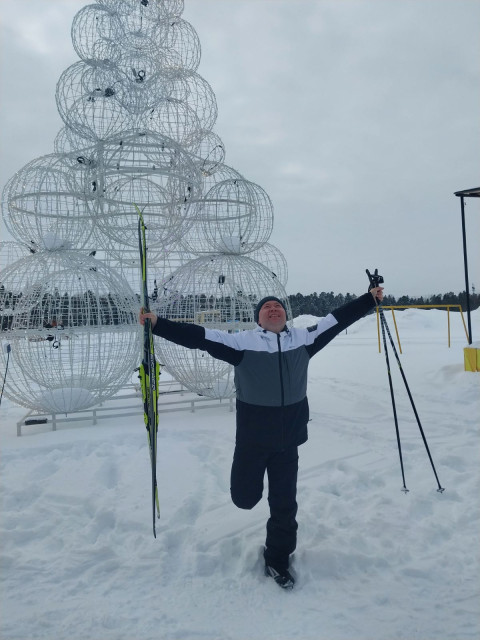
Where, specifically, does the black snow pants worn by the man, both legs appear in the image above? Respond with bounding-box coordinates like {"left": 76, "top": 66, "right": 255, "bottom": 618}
{"left": 230, "top": 445, "right": 298, "bottom": 571}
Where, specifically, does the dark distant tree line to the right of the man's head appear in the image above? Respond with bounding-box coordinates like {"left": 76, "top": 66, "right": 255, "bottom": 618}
{"left": 288, "top": 291, "right": 480, "bottom": 318}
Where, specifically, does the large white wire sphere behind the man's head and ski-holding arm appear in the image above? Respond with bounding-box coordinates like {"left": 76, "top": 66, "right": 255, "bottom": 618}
{"left": 152, "top": 255, "right": 291, "bottom": 398}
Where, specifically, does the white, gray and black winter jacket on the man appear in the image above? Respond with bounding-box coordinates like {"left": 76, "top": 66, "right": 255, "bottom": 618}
{"left": 154, "top": 293, "right": 375, "bottom": 450}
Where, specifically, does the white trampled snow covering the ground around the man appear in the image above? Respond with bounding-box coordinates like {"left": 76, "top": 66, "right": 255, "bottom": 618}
{"left": 0, "top": 310, "right": 480, "bottom": 640}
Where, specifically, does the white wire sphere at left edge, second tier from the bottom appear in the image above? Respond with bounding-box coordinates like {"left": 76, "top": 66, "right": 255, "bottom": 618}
{"left": 3, "top": 153, "right": 94, "bottom": 249}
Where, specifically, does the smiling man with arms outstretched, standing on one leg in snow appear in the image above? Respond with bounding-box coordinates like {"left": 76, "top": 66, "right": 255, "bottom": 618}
{"left": 140, "top": 287, "right": 383, "bottom": 589}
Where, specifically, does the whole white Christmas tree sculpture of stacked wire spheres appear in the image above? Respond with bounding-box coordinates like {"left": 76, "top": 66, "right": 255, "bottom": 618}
{"left": 0, "top": 0, "right": 291, "bottom": 413}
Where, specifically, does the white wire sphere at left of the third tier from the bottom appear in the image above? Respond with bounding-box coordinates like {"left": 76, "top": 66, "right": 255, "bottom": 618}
{"left": 55, "top": 60, "right": 134, "bottom": 141}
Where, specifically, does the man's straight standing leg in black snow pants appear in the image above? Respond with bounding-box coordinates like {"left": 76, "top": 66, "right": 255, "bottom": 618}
{"left": 264, "top": 447, "right": 298, "bottom": 571}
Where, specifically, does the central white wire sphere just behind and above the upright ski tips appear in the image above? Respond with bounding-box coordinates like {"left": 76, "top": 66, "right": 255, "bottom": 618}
{"left": 92, "top": 132, "right": 201, "bottom": 249}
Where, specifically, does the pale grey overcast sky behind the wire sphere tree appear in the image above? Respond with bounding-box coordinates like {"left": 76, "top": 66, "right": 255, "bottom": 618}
{"left": 0, "top": 0, "right": 480, "bottom": 296}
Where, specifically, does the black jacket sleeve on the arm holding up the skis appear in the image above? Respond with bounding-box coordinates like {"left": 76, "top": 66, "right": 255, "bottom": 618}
{"left": 153, "top": 318, "right": 243, "bottom": 365}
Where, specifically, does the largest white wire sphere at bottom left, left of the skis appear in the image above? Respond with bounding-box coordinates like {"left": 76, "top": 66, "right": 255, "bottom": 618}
{"left": 0, "top": 251, "right": 140, "bottom": 413}
